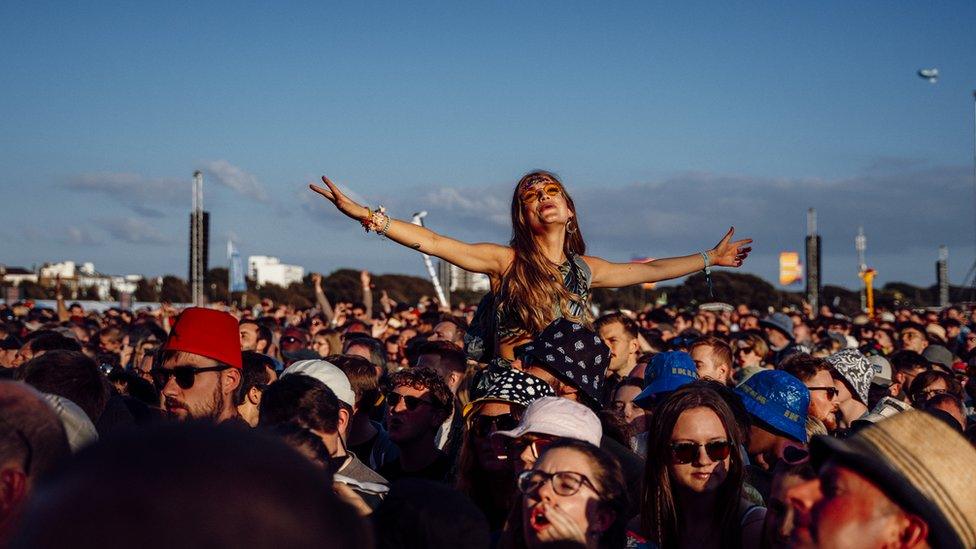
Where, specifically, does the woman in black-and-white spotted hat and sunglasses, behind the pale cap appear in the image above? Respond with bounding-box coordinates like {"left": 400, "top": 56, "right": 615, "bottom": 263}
{"left": 455, "top": 369, "right": 553, "bottom": 539}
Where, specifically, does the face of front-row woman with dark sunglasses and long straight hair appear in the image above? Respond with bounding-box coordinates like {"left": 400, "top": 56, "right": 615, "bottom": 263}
{"left": 668, "top": 407, "right": 732, "bottom": 493}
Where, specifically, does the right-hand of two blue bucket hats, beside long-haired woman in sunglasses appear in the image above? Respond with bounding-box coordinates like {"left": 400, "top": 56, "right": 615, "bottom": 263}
{"left": 735, "top": 370, "right": 810, "bottom": 443}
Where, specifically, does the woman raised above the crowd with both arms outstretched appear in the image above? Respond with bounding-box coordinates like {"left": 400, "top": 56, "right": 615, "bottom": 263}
{"left": 310, "top": 171, "right": 751, "bottom": 361}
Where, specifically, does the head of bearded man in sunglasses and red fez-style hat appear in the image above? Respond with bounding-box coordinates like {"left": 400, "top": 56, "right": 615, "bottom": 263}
{"left": 153, "top": 307, "right": 247, "bottom": 426}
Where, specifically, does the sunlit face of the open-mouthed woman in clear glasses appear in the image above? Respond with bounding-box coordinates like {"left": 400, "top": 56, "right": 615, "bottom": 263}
{"left": 522, "top": 448, "right": 613, "bottom": 547}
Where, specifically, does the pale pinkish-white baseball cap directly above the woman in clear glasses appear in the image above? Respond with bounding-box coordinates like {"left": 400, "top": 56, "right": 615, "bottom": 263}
{"left": 492, "top": 397, "right": 603, "bottom": 446}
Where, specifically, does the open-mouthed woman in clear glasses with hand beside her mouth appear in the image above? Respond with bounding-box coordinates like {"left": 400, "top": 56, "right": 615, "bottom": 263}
{"left": 500, "top": 439, "right": 627, "bottom": 549}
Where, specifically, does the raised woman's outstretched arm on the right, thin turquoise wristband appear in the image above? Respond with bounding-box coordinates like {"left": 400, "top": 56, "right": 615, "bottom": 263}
{"left": 586, "top": 228, "right": 752, "bottom": 288}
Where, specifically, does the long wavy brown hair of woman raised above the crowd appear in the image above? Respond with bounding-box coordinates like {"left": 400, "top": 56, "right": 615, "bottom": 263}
{"left": 500, "top": 170, "right": 592, "bottom": 334}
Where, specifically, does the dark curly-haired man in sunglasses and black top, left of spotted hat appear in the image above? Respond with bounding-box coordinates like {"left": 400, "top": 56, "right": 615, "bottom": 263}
{"left": 379, "top": 368, "right": 454, "bottom": 482}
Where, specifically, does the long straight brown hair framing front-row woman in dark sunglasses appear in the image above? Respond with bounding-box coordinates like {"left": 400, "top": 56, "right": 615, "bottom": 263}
{"left": 641, "top": 382, "right": 745, "bottom": 547}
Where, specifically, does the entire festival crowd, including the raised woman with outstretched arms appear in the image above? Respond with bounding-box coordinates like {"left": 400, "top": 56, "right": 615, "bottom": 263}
{"left": 0, "top": 172, "right": 976, "bottom": 548}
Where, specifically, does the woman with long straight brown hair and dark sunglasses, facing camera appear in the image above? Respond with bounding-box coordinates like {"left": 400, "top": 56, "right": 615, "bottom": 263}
{"left": 641, "top": 384, "right": 765, "bottom": 548}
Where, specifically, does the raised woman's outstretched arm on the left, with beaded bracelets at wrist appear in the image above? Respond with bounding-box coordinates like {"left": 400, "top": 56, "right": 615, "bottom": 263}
{"left": 309, "top": 176, "right": 514, "bottom": 276}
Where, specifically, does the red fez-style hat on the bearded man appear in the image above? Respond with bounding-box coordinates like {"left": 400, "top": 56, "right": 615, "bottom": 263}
{"left": 163, "top": 307, "right": 242, "bottom": 368}
